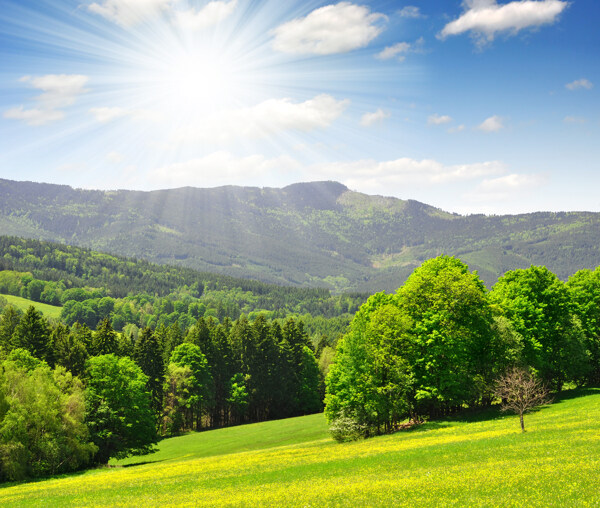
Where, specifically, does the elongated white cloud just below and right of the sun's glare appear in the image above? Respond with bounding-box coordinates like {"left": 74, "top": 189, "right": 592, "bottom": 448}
{"left": 176, "top": 94, "right": 350, "bottom": 142}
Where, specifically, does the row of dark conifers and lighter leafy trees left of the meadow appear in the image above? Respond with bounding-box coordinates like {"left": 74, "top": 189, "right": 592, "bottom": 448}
{"left": 0, "top": 305, "right": 324, "bottom": 480}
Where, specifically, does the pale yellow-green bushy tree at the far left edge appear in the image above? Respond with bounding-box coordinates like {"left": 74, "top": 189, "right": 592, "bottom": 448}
{"left": 0, "top": 349, "right": 96, "bottom": 481}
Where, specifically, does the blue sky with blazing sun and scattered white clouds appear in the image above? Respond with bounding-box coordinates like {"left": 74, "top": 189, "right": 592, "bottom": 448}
{"left": 0, "top": 0, "right": 600, "bottom": 214}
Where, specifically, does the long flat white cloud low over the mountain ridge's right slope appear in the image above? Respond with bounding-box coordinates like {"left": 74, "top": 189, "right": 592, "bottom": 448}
{"left": 309, "top": 157, "right": 505, "bottom": 188}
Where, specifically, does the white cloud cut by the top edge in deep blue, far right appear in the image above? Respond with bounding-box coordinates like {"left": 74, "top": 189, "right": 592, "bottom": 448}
{"left": 438, "top": 0, "right": 569, "bottom": 45}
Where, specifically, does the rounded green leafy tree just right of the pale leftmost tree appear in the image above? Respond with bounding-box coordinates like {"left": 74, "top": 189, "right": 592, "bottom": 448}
{"left": 85, "top": 354, "right": 157, "bottom": 464}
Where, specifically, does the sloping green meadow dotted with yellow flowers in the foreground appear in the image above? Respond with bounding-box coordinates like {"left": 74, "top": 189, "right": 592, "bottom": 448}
{"left": 0, "top": 389, "right": 600, "bottom": 507}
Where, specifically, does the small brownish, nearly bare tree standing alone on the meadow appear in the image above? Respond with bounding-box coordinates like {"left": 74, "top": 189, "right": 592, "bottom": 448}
{"left": 495, "top": 367, "right": 550, "bottom": 432}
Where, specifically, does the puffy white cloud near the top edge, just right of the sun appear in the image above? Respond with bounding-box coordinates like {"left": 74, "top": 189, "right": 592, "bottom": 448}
{"left": 273, "top": 2, "right": 387, "bottom": 55}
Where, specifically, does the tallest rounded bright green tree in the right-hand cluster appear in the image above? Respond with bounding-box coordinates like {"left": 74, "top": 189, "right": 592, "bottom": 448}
{"left": 397, "top": 256, "right": 494, "bottom": 416}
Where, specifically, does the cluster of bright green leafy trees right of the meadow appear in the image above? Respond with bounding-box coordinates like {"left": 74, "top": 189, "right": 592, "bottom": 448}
{"left": 325, "top": 256, "right": 600, "bottom": 439}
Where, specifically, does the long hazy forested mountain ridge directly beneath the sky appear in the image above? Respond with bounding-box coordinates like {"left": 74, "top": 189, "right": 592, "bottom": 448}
{"left": 0, "top": 179, "right": 600, "bottom": 291}
